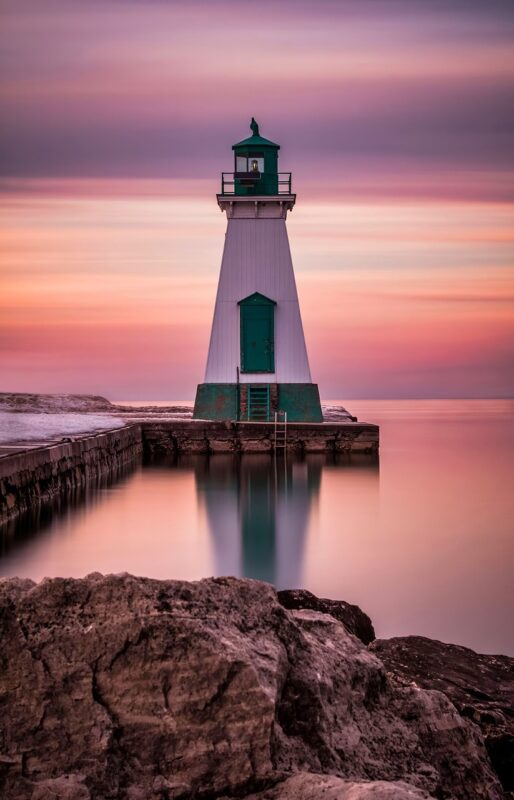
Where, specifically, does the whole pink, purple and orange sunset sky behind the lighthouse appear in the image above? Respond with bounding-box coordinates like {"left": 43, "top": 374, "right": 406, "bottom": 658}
{"left": 0, "top": 0, "right": 514, "bottom": 399}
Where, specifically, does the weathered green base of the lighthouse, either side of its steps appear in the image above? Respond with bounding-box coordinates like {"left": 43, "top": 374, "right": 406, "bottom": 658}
{"left": 193, "top": 382, "right": 323, "bottom": 422}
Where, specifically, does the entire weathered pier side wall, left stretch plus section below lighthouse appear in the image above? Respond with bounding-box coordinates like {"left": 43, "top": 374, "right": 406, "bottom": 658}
{"left": 0, "top": 419, "right": 379, "bottom": 524}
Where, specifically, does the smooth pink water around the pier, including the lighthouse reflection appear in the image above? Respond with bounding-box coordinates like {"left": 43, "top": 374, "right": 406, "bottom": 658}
{"left": 0, "top": 401, "right": 514, "bottom": 654}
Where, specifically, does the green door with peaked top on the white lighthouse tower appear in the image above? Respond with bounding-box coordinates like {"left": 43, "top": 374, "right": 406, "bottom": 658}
{"left": 239, "top": 292, "right": 276, "bottom": 372}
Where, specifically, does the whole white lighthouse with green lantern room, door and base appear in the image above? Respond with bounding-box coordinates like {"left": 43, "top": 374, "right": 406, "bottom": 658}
{"left": 193, "top": 118, "right": 323, "bottom": 422}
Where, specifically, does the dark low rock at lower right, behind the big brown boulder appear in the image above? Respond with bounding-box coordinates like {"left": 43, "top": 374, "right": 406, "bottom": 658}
{"left": 371, "top": 636, "right": 514, "bottom": 792}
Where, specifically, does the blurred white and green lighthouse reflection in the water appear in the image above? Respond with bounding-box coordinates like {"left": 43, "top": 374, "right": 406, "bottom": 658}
{"left": 195, "top": 455, "right": 378, "bottom": 589}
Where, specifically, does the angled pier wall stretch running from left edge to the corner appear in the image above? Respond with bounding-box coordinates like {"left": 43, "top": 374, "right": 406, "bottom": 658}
{"left": 0, "top": 425, "right": 143, "bottom": 523}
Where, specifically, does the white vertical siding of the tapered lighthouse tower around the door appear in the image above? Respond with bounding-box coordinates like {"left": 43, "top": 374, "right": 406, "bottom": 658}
{"left": 205, "top": 210, "right": 312, "bottom": 383}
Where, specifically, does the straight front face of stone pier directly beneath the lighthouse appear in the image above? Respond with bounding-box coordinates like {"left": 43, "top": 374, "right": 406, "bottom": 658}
{"left": 142, "top": 420, "right": 379, "bottom": 455}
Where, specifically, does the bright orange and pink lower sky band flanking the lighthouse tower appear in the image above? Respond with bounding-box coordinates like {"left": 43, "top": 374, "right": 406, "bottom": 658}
{"left": 0, "top": 187, "right": 514, "bottom": 399}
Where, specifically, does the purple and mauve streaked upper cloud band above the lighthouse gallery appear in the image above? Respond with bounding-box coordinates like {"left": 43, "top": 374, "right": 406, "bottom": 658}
{"left": 0, "top": 0, "right": 514, "bottom": 199}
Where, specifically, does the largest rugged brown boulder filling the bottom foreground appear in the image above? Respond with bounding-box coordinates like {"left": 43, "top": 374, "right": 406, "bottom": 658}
{"left": 0, "top": 575, "right": 502, "bottom": 800}
